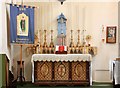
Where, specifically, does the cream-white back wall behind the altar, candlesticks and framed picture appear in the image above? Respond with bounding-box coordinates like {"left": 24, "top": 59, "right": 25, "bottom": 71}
{"left": 0, "top": 2, "right": 118, "bottom": 82}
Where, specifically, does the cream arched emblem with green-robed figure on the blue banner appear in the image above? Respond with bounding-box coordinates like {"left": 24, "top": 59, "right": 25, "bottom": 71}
{"left": 17, "top": 13, "right": 29, "bottom": 36}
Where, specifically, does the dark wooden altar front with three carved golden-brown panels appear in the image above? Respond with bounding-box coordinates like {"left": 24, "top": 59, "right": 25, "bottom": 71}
{"left": 34, "top": 61, "right": 90, "bottom": 85}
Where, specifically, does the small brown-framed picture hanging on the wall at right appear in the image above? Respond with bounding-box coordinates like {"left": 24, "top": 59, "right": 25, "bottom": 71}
{"left": 106, "top": 26, "right": 117, "bottom": 44}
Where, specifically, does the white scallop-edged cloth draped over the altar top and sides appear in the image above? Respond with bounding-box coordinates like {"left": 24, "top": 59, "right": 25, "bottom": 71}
{"left": 31, "top": 54, "right": 92, "bottom": 85}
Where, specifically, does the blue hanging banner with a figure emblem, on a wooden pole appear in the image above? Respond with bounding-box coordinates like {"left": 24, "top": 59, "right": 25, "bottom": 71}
{"left": 10, "top": 4, "right": 34, "bottom": 44}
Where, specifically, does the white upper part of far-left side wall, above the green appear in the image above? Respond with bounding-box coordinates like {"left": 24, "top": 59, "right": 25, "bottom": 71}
{"left": 0, "top": 0, "right": 10, "bottom": 65}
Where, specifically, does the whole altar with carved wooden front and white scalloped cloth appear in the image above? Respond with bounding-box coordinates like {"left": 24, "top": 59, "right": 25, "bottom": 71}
{"left": 31, "top": 54, "right": 92, "bottom": 86}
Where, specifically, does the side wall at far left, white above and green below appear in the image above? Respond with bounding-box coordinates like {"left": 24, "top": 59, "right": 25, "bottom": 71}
{"left": 0, "top": 0, "right": 10, "bottom": 88}
